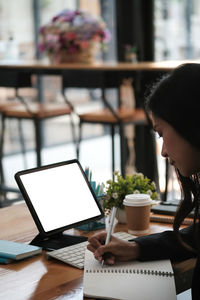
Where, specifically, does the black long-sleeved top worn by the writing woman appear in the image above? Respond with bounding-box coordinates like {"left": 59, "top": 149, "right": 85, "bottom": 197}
{"left": 135, "top": 226, "right": 200, "bottom": 300}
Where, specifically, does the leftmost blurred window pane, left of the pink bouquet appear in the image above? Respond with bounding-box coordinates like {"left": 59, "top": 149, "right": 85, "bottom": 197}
{"left": 0, "top": 0, "right": 34, "bottom": 60}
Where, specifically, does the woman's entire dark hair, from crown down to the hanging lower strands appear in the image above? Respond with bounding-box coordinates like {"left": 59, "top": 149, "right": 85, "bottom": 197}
{"left": 145, "top": 63, "right": 200, "bottom": 250}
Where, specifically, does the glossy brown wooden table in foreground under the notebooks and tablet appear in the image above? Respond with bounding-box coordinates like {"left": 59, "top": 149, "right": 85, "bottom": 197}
{"left": 0, "top": 203, "right": 195, "bottom": 300}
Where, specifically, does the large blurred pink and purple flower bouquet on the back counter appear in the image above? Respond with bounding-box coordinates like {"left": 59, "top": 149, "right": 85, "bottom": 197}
{"left": 38, "top": 9, "right": 110, "bottom": 62}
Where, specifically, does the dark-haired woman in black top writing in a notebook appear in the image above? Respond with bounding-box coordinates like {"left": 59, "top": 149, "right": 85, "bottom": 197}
{"left": 88, "top": 64, "right": 200, "bottom": 300}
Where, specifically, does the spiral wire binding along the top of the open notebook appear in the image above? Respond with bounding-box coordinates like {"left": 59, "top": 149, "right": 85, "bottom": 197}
{"left": 85, "top": 268, "right": 174, "bottom": 277}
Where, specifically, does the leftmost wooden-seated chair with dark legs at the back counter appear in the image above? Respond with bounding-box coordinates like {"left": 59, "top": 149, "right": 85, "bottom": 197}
{"left": 0, "top": 73, "right": 76, "bottom": 183}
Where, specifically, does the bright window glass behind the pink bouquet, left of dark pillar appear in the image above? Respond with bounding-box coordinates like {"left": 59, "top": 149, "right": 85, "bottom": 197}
{"left": 0, "top": 0, "right": 115, "bottom": 60}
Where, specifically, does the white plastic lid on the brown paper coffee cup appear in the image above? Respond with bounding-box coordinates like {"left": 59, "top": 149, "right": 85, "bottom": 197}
{"left": 123, "top": 194, "right": 152, "bottom": 206}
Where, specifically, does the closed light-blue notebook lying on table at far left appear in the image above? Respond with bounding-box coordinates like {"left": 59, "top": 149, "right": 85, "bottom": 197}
{"left": 0, "top": 240, "right": 42, "bottom": 263}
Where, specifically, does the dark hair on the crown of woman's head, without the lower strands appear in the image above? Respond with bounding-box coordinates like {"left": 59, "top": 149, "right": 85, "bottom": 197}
{"left": 146, "top": 63, "right": 200, "bottom": 150}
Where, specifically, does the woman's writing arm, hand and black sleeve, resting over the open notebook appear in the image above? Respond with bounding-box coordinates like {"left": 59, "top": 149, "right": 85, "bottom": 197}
{"left": 87, "top": 227, "right": 196, "bottom": 264}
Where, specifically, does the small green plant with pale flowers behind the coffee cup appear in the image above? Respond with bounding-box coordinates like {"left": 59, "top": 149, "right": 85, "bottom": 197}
{"left": 105, "top": 172, "right": 158, "bottom": 211}
